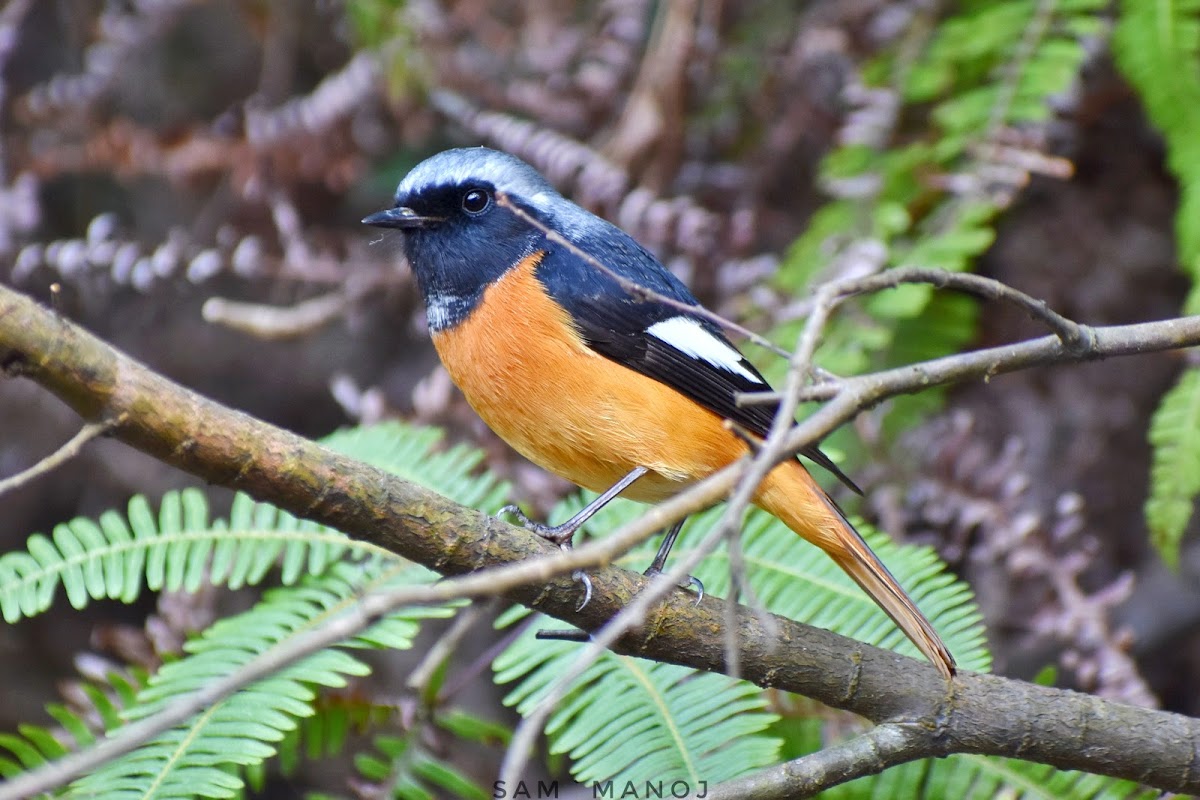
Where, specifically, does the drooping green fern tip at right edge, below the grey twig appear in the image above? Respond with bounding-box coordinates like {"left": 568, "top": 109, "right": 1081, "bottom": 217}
{"left": 1146, "top": 367, "right": 1200, "bottom": 566}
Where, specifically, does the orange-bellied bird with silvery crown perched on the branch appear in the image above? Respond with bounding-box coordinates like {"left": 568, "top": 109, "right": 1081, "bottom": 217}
{"left": 362, "top": 148, "right": 954, "bottom": 678}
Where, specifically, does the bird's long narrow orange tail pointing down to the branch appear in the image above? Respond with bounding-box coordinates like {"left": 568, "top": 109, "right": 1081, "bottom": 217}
{"left": 755, "top": 462, "right": 955, "bottom": 680}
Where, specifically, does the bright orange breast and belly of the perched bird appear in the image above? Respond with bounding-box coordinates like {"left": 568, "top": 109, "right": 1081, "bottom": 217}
{"left": 433, "top": 253, "right": 746, "bottom": 503}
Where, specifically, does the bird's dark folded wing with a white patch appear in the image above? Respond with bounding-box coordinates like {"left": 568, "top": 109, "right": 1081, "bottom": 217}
{"left": 538, "top": 237, "right": 863, "bottom": 494}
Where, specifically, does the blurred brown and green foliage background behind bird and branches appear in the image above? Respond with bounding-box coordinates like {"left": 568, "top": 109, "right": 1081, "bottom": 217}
{"left": 0, "top": 0, "right": 1200, "bottom": 796}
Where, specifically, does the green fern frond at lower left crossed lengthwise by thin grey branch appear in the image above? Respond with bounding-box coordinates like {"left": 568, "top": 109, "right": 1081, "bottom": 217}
{"left": 71, "top": 561, "right": 452, "bottom": 799}
